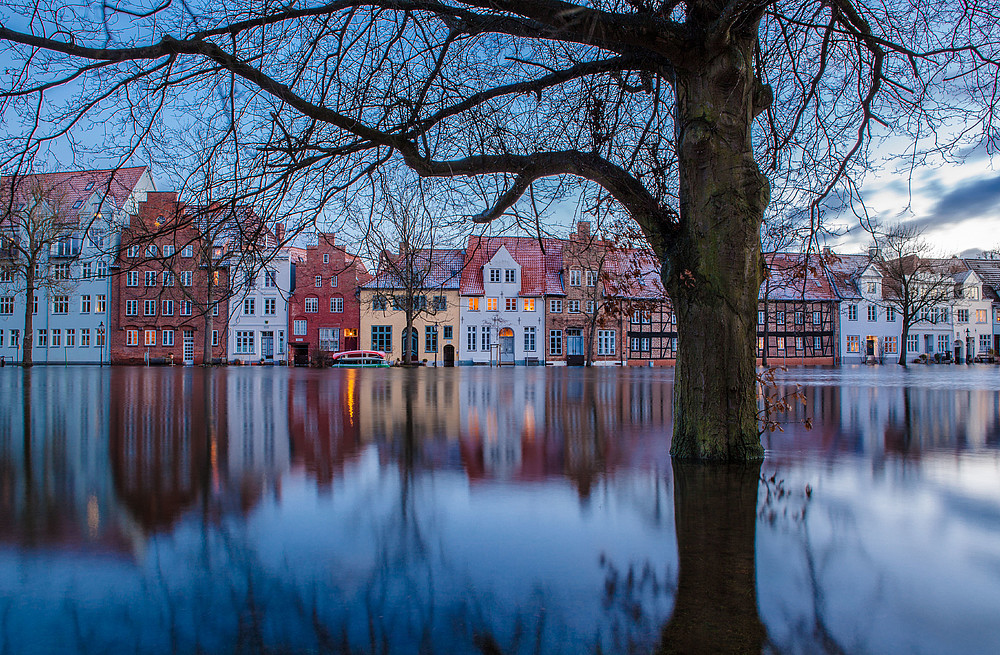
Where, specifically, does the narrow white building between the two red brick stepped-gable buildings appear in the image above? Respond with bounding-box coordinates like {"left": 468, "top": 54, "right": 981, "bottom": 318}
{"left": 227, "top": 251, "right": 292, "bottom": 363}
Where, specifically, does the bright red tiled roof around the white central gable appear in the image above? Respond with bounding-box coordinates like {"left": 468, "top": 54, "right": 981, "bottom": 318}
{"left": 459, "top": 236, "right": 564, "bottom": 296}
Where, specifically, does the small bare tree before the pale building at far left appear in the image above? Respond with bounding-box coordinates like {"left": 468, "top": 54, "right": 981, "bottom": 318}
{"left": 0, "top": 177, "right": 81, "bottom": 367}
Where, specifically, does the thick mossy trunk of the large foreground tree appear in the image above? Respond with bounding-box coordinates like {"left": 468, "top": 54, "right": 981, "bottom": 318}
{"left": 663, "top": 29, "right": 769, "bottom": 460}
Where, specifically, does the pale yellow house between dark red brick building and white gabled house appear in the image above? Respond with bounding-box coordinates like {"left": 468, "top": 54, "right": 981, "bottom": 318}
{"left": 360, "top": 249, "right": 465, "bottom": 366}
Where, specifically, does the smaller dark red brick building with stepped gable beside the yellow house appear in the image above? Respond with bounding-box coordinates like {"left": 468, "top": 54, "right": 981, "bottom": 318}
{"left": 288, "top": 233, "right": 371, "bottom": 366}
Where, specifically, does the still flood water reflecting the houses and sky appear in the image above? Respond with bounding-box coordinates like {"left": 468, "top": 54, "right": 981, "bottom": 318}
{"left": 0, "top": 366, "right": 1000, "bottom": 653}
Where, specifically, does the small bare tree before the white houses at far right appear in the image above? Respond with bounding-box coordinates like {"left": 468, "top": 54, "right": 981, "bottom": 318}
{"left": 871, "top": 224, "right": 955, "bottom": 366}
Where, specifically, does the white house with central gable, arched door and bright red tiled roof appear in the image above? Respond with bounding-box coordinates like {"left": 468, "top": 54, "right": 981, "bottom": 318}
{"left": 459, "top": 237, "right": 564, "bottom": 365}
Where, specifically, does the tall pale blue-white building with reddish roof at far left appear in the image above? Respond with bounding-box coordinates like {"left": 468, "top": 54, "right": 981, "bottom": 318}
{"left": 0, "top": 166, "right": 155, "bottom": 364}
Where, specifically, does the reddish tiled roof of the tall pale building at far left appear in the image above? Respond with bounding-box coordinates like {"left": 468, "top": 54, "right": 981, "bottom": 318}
{"left": 0, "top": 166, "right": 148, "bottom": 221}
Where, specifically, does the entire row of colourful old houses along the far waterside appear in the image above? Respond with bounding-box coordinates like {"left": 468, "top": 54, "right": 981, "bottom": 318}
{"left": 0, "top": 167, "right": 1000, "bottom": 366}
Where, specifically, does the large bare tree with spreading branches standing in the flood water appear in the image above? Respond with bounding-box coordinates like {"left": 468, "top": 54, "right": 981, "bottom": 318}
{"left": 0, "top": 0, "right": 1000, "bottom": 459}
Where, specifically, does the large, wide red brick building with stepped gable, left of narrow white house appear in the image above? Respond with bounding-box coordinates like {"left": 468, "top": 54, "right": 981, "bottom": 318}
{"left": 108, "top": 191, "right": 230, "bottom": 364}
